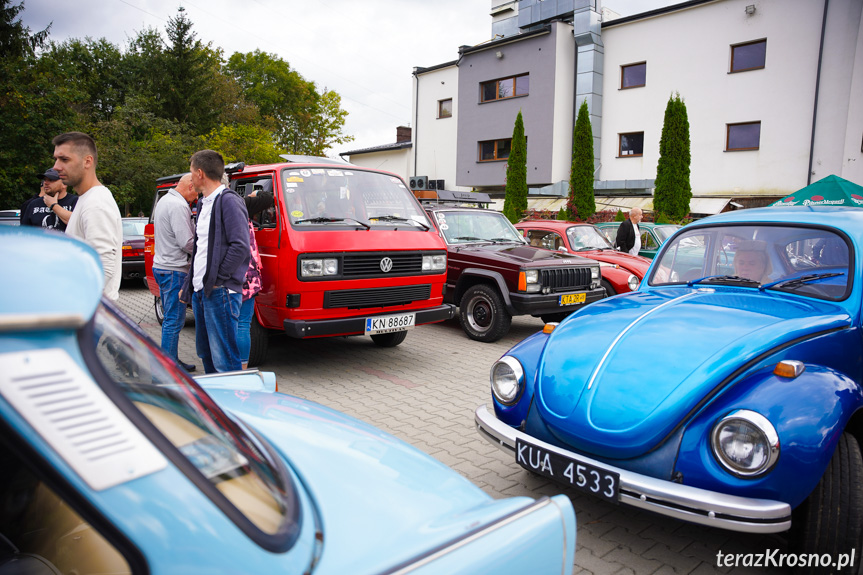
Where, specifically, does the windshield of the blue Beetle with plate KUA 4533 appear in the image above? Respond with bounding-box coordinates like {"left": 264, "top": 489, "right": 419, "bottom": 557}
{"left": 650, "top": 225, "right": 853, "bottom": 300}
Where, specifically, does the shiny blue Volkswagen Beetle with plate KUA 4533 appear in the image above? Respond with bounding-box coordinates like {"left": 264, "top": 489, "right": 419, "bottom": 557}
{"left": 475, "top": 207, "right": 863, "bottom": 557}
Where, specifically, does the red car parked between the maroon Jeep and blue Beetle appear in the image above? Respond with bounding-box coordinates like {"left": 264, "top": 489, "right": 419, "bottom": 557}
{"left": 515, "top": 220, "right": 650, "bottom": 296}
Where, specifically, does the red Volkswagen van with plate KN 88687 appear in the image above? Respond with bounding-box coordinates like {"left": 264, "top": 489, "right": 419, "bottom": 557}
{"left": 146, "top": 155, "right": 455, "bottom": 365}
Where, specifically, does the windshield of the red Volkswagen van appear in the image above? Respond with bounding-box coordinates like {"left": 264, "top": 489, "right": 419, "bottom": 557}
{"left": 281, "top": 168, "right": 430, "bottom": 231}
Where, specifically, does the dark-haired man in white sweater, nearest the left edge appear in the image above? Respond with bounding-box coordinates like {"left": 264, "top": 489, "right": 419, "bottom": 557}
{"left": 52, "top": 132, "right": 123, "bottom": 301}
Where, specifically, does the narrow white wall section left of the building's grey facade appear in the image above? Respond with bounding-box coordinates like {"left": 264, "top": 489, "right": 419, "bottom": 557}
{"left": 409, "top": 64, "right": 470, "bottom": 190}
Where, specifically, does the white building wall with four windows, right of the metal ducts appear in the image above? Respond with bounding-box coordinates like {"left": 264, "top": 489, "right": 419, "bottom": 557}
{"left": 599, "top": 0, "right": 828, "bottom": 195}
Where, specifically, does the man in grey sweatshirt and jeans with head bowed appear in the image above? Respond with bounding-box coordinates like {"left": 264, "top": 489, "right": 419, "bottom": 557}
{"left": 153, "top": 174, "right": 198, "bottom": 371}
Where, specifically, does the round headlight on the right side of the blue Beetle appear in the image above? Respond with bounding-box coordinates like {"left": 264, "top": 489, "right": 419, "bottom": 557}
{"left": 710, "top": 409, "right": 779, "bottom": 477}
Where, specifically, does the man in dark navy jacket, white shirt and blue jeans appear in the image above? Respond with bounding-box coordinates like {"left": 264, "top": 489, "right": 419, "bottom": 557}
{"left": 180, "top": 150, "right": 251, "bottom": 373}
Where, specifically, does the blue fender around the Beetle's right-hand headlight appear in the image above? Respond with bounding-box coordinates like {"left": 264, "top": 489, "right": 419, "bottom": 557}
{"left": 675, "top": 364, "right": 863, "bottom": 507}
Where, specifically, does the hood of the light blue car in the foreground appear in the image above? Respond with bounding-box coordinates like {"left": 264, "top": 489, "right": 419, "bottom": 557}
{"left": 208, "top": 390, "right": 532, "bottom": 573}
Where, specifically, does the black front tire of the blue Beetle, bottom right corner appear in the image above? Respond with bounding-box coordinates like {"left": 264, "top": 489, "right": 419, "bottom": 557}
{"left": 789, "top": 433, "right": 863, "bottom": 573}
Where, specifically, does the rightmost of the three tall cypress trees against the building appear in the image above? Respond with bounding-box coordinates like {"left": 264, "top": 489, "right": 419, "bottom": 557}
{"left": 653, "top": 93, "right": 692, "bottom": 221}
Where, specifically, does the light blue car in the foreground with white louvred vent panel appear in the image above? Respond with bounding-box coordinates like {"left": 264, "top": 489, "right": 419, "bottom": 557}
{"left": 0, "top": 227, "right": 575, "bottom": 575}
